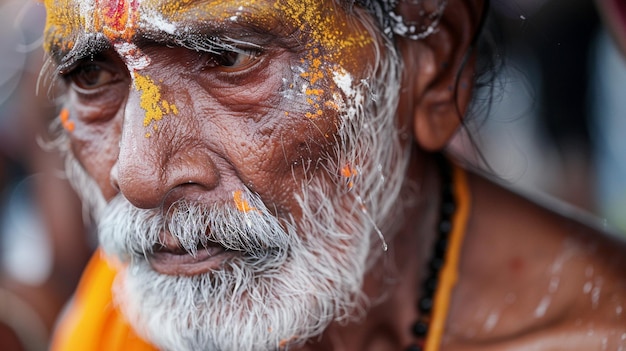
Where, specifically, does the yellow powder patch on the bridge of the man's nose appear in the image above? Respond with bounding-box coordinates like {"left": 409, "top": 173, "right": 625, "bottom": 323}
{"left": 133, "top": 72, "right": 178, "bottom": 136}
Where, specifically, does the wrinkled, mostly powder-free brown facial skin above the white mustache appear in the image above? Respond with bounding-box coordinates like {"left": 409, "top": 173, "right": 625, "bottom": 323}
{"left": 47, "top": 2, "right": 372, "bottom": 217}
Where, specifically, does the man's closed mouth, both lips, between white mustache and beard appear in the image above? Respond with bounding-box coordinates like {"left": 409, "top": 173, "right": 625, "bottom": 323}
{"left": 148, "top": 234, "right": 241, "bottom": 276}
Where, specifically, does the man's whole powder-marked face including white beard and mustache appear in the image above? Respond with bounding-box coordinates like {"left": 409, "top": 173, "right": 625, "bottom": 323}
{"left": 45, "top": 0, "right": 406, "bottom": 350}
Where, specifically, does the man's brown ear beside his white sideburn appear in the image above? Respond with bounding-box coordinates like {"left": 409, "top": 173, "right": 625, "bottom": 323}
{"left": 397, "top": 0, "right": 483, "bottom": 151}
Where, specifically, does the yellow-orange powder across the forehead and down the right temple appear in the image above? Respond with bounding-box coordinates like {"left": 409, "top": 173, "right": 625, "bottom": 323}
{"left": 142, "top": 0, "right": 373, "bottom": 118}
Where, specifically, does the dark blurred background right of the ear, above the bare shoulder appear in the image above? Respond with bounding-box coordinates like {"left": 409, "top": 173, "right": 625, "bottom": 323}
{"left": 451, "top": 0, "right": 626, "bottom": 235}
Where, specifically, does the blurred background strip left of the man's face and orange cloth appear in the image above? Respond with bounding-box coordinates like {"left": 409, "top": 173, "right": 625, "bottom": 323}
{"left": 0, "top": 0, "right": 93, "bottom": 351}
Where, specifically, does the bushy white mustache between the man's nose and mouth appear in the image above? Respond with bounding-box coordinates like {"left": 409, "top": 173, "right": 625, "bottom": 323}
{"left": 98, "top": 191, "right": 295, "bottom": 261}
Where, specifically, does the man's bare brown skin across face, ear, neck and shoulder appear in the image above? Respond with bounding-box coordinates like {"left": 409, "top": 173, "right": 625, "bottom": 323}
{"left": 46, "top": 0, "right": 626, "bottom": 350}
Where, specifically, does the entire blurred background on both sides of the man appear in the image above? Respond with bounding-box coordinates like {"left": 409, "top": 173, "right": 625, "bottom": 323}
{"left": 0, "top": 0, "right": 626, "bottom": 351}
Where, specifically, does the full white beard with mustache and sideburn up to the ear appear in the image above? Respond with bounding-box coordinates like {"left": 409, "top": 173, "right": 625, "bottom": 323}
{"left": 63, "top": 21, "right": 408, "bottom": 351}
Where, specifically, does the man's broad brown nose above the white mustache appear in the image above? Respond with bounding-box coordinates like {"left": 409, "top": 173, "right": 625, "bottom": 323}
{"left": 111, "top": 87, "right": 219, "bottom": 209}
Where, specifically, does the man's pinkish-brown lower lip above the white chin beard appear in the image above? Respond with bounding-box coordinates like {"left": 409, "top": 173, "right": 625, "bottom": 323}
{"left": 150, "top": 247, "right": 239, "bottom": 276}
